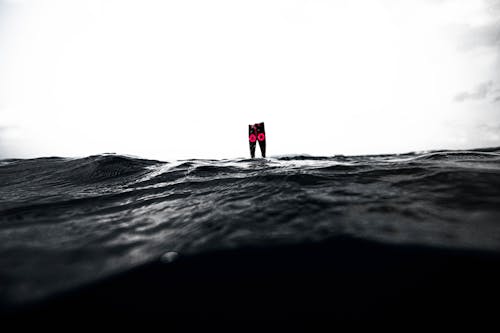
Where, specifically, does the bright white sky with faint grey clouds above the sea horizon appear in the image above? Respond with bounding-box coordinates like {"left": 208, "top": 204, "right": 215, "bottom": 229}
{"left": 0, "top": 0, "right": 500, "bottom": 160}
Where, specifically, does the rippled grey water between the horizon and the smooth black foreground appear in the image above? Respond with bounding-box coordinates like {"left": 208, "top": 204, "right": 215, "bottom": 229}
{"left": 0, "top": 148, "right": 500, "bottom": 320}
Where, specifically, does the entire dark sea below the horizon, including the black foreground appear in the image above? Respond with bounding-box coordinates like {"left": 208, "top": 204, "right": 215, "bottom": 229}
{"left": 0, "top": 148, "right": 500, "bottom": 322}
